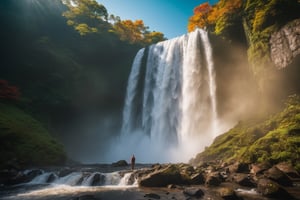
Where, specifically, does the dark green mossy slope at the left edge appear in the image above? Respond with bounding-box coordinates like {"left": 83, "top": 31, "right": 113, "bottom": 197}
{"left": 0, "top": 103, "right": 66, "bottom": 168}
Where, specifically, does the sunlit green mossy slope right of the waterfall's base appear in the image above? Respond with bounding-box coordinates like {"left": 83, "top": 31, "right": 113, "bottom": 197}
{"left": 191, "top": 95, "right": 300, "bottom": 170}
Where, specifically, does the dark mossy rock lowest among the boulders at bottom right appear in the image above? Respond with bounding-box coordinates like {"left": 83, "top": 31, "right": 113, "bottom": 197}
{"left": 257, "top": 178, "right": 293, "bottom": 199}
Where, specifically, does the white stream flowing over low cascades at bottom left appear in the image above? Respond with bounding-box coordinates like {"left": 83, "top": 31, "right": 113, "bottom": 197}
{"left": 0, "top": 167, "right": 138, "bottom": 200}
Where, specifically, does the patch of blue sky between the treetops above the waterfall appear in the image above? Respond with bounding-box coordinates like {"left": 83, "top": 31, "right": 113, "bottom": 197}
{"left": 97, "top": 0, "right": 218, "bottom": 39}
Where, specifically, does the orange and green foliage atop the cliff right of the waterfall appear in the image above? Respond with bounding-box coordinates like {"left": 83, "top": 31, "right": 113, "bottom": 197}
{"left": 188, "top": 0, "right": 300, "bottom": 76}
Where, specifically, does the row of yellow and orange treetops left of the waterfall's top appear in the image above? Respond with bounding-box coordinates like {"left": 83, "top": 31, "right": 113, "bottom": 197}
{"left": 63, "top": 0, "right": 165, "bottom": 46}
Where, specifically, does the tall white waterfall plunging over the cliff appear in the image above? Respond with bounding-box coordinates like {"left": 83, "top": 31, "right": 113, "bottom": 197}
{"left": 119, "top": 29, "right": 218, "bottom": 162}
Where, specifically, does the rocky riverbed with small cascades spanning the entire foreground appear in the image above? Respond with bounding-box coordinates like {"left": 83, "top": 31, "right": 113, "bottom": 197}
{"left": 0, "top": 162, "right": 300, "bottom": 200}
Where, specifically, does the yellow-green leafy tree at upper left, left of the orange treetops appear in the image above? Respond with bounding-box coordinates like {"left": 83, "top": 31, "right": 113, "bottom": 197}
{"left": 63, "top": 0, "right": 109, "bottom": 35}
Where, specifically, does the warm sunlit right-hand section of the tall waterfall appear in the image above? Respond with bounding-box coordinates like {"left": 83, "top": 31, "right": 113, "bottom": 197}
{"left": 178, "top": 30, "right": 218, "bottom": 157}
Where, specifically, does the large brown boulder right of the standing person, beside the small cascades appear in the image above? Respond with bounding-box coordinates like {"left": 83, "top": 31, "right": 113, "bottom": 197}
{"left": 138, "top": 165, "right": 184, "bottom": 187}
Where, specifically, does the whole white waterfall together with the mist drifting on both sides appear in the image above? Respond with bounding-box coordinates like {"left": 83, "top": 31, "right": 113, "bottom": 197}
{"left": 62, "top": 30, "right": 259, "bottom": 163}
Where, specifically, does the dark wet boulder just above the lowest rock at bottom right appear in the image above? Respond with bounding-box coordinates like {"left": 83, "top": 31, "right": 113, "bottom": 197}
{"left": 264, "top": 166, "right": 293, "bottom": 186}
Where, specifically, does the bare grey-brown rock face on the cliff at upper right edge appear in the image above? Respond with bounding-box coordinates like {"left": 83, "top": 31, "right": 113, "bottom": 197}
{"left": 270, "top": 19, "right": 300, "bottom": 69}
